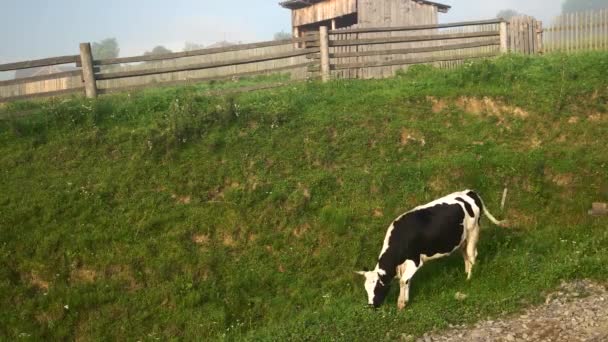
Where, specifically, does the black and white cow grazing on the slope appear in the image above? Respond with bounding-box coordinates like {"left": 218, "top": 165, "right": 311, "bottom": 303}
{"left": 357, "top": 190, "right": 506, "bottom": 309}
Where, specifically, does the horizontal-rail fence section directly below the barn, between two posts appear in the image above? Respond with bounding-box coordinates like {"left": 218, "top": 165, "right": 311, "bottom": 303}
{"left": 308, "top": 19, "right": 507, "bottom": 79}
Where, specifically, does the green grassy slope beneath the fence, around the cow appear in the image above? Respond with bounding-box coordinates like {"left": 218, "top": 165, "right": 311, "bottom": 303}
{"left": 0, "top": 53, "right": 608, "bottom": 340}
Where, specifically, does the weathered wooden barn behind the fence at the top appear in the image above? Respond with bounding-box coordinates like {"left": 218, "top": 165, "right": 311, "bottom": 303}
{"left": 280, "top": 0, "right": 450, "bottom": 37}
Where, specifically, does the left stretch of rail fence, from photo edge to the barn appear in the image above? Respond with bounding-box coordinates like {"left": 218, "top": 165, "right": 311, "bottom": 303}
{"left": 0, "top": 33, "right": 320, "bottom": 102}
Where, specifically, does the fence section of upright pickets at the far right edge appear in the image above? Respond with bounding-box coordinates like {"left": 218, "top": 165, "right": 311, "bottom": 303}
{"left": 543, "top": 8, "right": 608, "bottom": 52}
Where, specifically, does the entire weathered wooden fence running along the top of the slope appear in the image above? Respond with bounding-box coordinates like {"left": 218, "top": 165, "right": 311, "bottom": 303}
{"left": 5, "top": 10, "right": 608, "bottom": 102}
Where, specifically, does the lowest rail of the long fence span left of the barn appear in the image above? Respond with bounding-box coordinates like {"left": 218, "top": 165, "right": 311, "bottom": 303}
{"left": 99, "top": 62, "right": 318, "bottom": 94}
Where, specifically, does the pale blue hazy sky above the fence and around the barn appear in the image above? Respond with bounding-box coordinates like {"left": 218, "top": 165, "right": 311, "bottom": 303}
{"left": 0, "top": 0, "right": 561, "bottom": 63}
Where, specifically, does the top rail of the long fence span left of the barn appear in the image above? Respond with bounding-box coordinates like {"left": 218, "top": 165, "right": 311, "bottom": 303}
{"left": 77, "top": 34, "right": 319, "bottom": 65}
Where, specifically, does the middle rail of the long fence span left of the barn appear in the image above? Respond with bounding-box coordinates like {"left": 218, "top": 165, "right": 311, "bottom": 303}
{"left": 96, "top": 48, "right": 320, "bottom": 80}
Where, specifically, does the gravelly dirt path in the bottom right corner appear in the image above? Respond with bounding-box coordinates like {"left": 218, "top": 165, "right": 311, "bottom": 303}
{"left": 418, "top": 281, "right": 608, "bottom": 342}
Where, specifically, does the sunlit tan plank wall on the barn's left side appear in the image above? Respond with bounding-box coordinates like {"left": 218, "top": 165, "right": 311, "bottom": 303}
{"left": 292, "top": 0, "right": 357, "bottom": 27}
